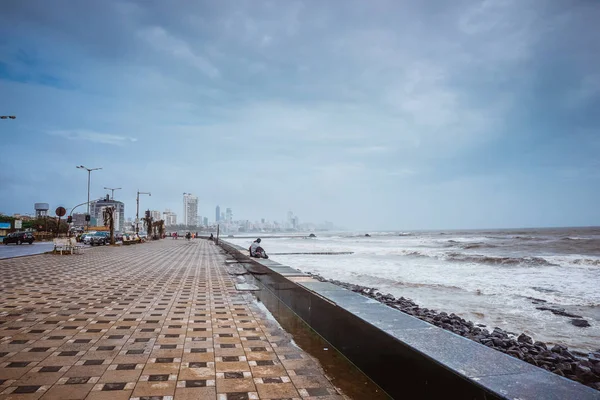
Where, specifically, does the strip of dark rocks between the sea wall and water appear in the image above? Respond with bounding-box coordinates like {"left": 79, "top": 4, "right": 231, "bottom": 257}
{"left": 309, "top": 274, "right": 600, "bottom": 390}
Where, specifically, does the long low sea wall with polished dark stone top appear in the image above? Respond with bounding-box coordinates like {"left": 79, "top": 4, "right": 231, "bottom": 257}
{"left": 220, "top": 241, "right": 600, "bottom": 400}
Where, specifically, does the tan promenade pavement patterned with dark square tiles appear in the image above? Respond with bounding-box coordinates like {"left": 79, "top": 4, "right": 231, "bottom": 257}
{"left": 0, "top": 239, "right": 343, "bottom": 400}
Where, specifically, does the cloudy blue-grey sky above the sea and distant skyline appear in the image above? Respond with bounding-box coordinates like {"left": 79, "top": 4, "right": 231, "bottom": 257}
{"left": 0, "top": 0, "right": 600, "bottom": 230}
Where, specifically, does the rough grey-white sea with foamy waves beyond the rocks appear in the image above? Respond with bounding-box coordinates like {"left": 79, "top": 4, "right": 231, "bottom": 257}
{"left": 230, "top": 227, "right": 600, "bottom": 351}
